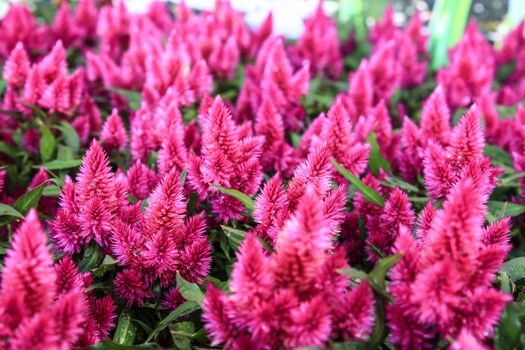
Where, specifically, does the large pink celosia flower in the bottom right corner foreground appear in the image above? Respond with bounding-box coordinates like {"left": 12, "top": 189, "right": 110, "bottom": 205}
{"left": 390, "top": 177, "right": 510, "bottom": 344}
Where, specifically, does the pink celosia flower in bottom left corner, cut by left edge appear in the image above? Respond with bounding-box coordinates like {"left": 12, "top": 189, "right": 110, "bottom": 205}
{"left": 0, "top": 210, "right": 86, "bottom": 349}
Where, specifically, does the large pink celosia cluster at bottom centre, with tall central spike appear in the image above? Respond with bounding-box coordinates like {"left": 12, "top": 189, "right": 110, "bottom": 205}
{"left": 204, "top": 187, "right": 374, "bottom": 348}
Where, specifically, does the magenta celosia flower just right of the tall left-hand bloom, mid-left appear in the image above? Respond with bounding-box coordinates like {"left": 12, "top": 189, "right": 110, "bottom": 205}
{"left": 112, "top": 169, "right": 211, "bottom": 292}
